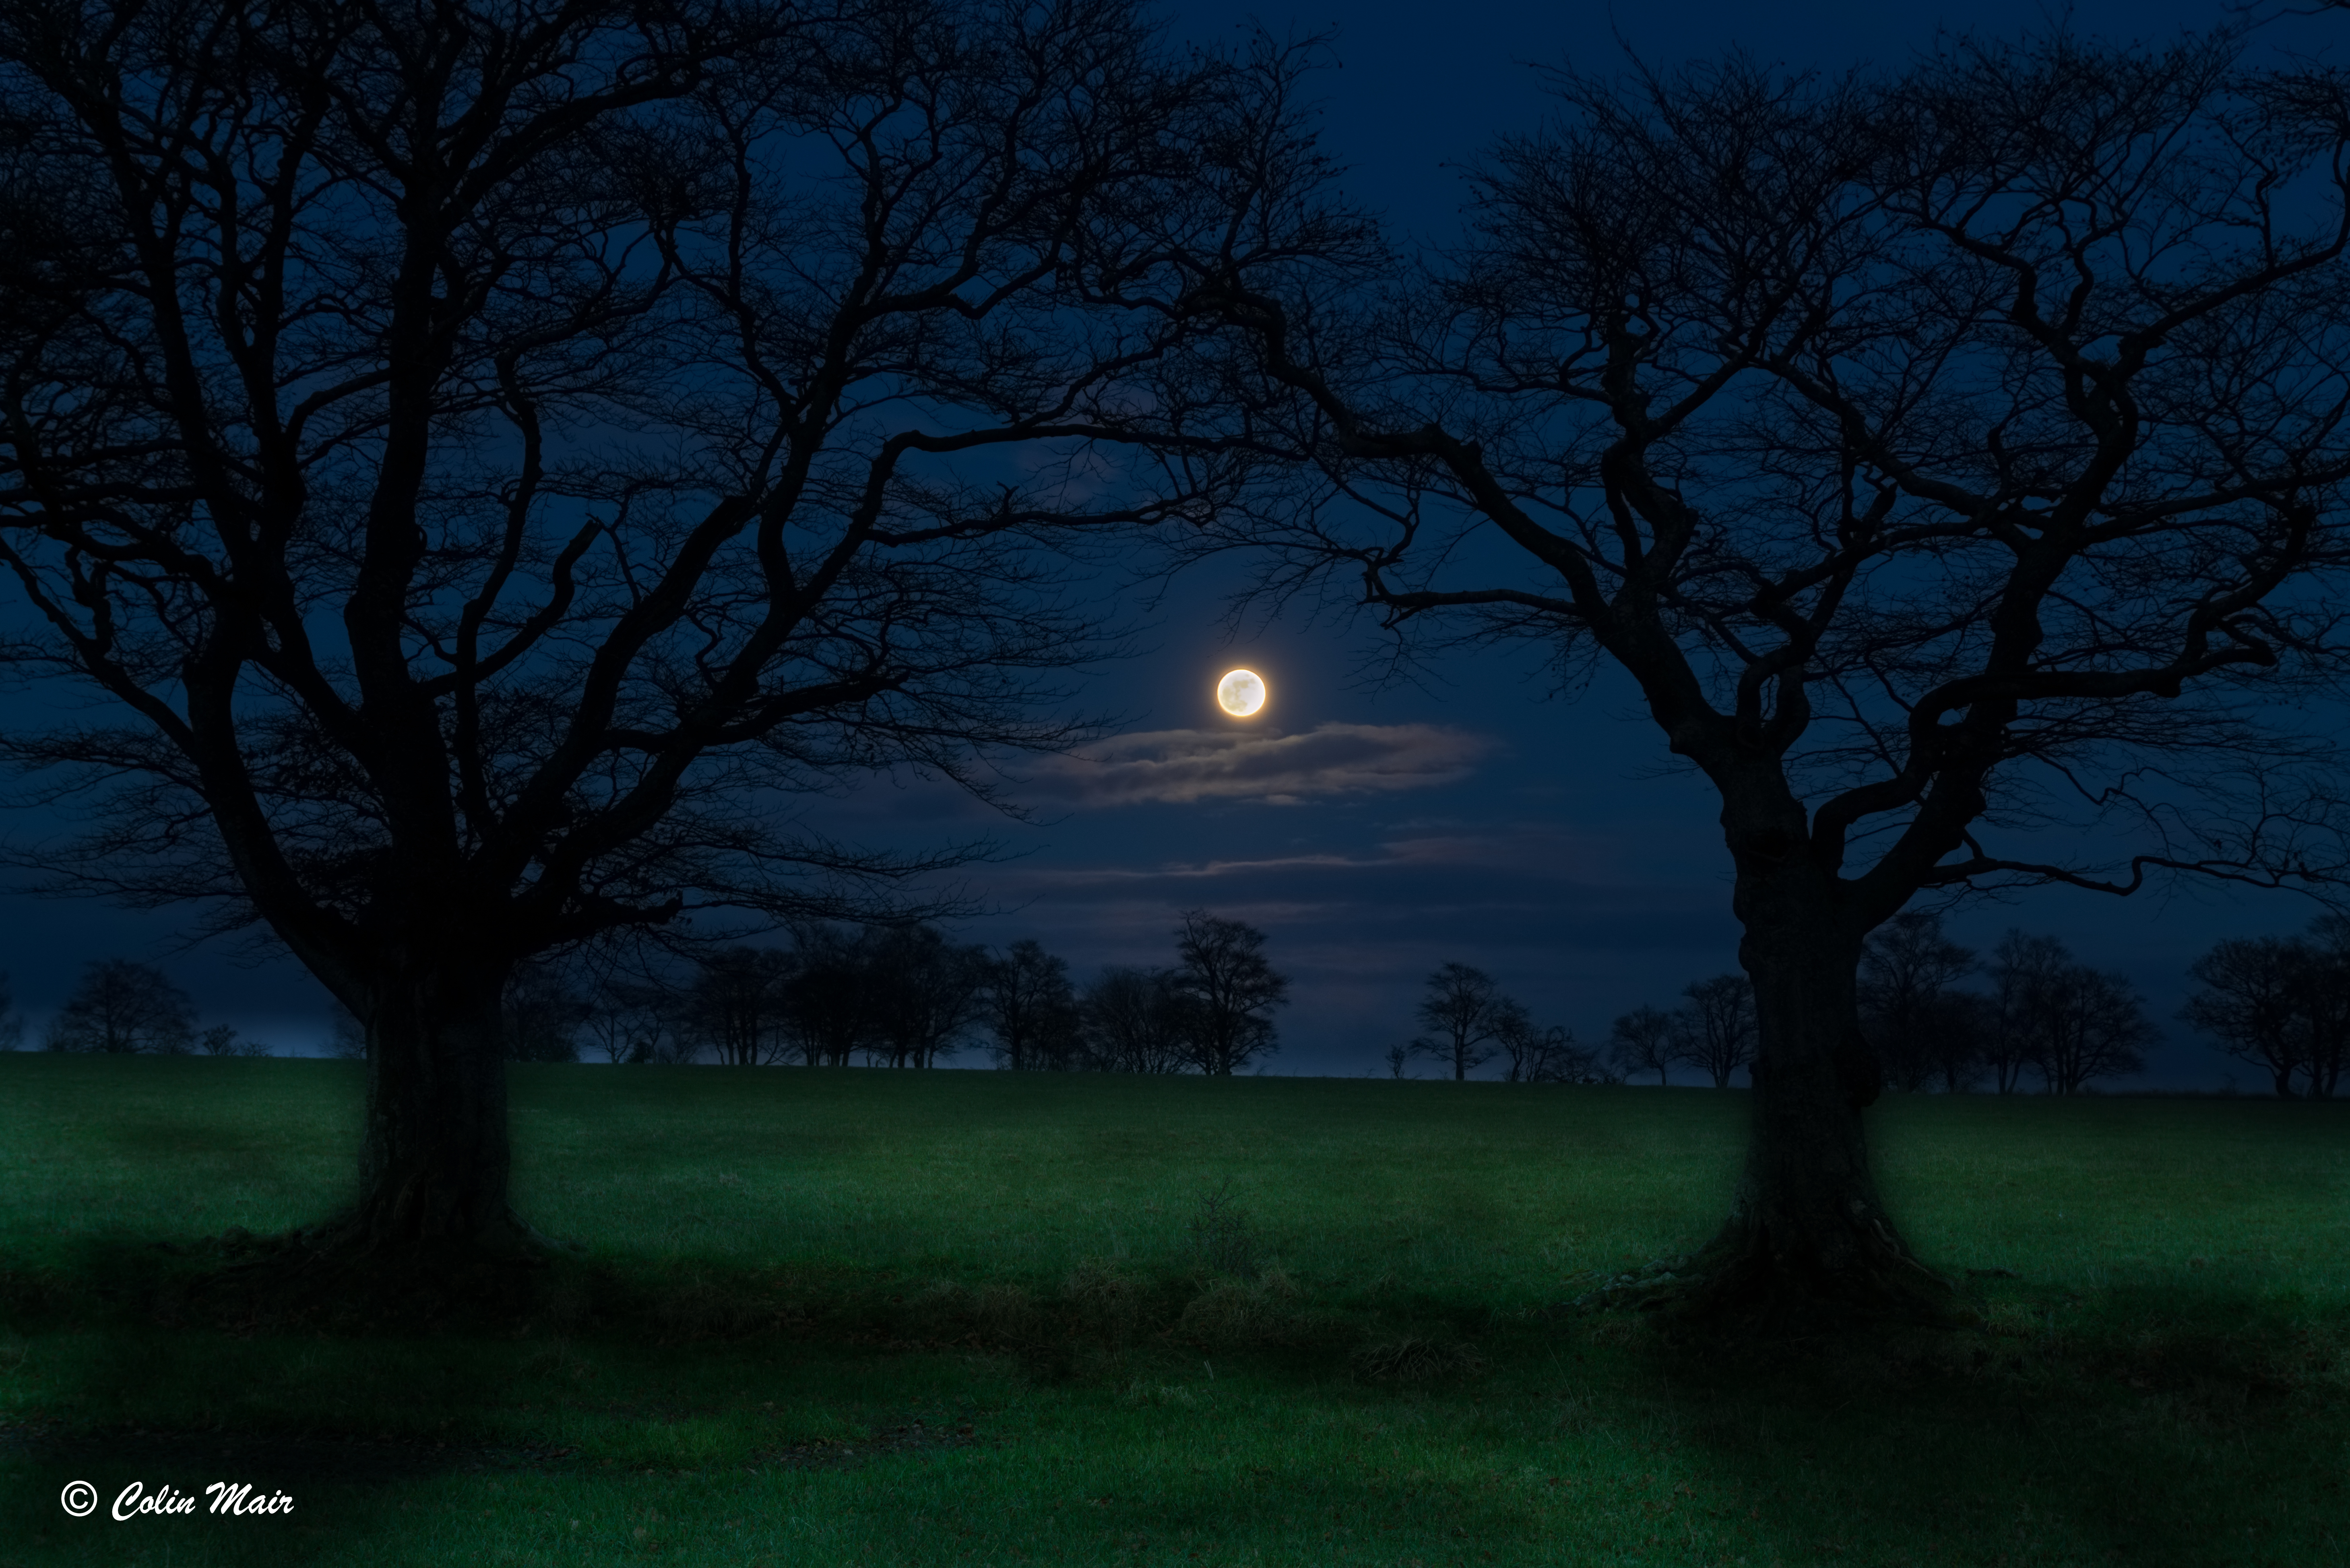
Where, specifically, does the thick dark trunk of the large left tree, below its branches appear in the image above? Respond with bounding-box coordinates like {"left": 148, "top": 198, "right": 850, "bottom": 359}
{"left": 324, "top": 971, "right": 536, "bottom": 1255}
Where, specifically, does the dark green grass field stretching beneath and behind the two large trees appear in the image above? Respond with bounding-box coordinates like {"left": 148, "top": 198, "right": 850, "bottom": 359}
{"left": 0, "top": 1056, "right": 2350, "bottom": 1568}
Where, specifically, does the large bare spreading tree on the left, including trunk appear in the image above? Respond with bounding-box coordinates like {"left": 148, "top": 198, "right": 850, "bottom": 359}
{"left": 0, "top": 0, "right": 1354, "bottom": 1253}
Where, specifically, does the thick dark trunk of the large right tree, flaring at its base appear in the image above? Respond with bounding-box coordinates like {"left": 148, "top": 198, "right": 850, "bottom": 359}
{"left": 1687, "top": 865, "right": 1948, "bottom": 1333}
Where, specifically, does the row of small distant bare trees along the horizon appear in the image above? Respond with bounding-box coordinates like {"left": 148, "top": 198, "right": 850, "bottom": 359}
{"left": 18, "top": 910, "right": 2350, "bottom": 1100}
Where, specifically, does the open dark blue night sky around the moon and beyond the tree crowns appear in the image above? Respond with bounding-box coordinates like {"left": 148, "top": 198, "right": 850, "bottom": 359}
{"left": 0, "top": 0, "right": 2350, "bottom": 1086}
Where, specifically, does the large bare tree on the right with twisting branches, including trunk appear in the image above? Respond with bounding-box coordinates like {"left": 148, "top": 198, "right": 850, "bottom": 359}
{"left": 1196, "top": 35, "right": 2350, "bottom": 1326}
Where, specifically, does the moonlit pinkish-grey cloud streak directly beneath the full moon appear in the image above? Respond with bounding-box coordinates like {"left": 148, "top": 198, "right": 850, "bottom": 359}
{"left": 1032, "top": 724, "right": 1492, "bottom": 806}
